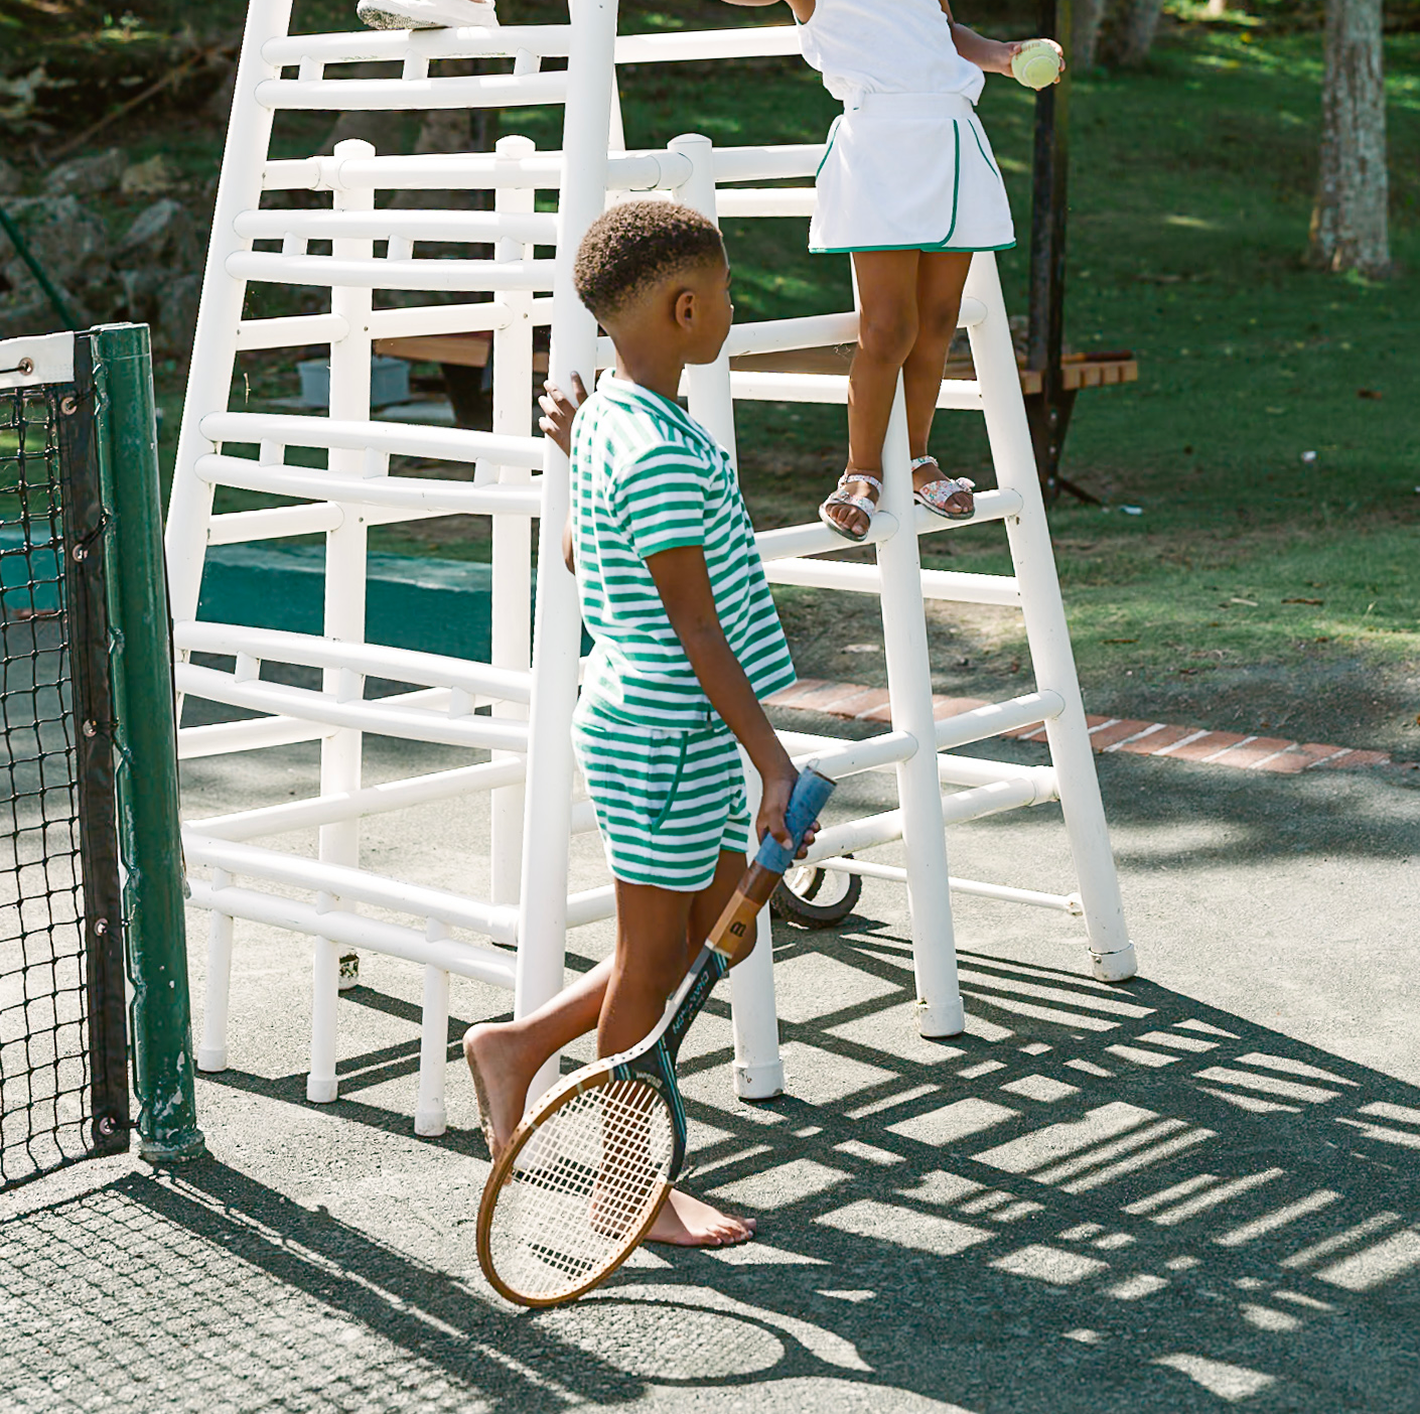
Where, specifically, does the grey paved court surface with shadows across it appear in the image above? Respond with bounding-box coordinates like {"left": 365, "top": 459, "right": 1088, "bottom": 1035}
{"left": 0, "top": 721, "right": 1420, "bottom": 1414}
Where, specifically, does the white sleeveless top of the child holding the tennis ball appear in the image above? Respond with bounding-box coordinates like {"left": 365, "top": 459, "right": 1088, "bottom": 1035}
{"left": 799, "top": 0, "right": 985, "bottom": 102}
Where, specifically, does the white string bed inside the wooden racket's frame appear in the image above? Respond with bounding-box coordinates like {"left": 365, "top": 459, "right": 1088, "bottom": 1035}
{"left": 488, "top": 1080, "right": 675, "bottom": 1302}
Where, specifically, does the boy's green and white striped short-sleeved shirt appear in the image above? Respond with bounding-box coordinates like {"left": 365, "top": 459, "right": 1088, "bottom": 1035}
{"left": 572, "top": 372, "right": 794, "bottom": 730}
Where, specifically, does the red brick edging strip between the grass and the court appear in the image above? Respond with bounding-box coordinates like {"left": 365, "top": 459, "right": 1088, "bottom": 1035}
{"left": 767, "top": 677, "right": 1420, "bottom": 775}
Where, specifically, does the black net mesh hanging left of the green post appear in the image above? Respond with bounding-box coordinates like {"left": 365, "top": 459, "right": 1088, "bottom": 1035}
{"left": 0, "top": 389, "right": 92, "bottom": 1187}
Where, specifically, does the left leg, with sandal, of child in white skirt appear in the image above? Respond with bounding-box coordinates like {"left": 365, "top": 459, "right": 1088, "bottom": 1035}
{"left": 828, "top": 250, "right": 922, "bottom": 534}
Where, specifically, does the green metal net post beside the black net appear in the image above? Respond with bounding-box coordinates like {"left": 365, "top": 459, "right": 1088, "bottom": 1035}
{"left": 89, "top": 324, "right": 206, "bottom": 1161}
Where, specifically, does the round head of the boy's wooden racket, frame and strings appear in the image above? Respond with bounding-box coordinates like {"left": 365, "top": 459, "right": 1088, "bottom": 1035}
{"left": 479, "top": 1061, "right": 684, "bottom": 1308}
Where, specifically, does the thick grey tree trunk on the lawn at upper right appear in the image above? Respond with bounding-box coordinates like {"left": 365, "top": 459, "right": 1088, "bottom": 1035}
{"left": 1311, "top": 0, "right": 1390, "bottom": 275}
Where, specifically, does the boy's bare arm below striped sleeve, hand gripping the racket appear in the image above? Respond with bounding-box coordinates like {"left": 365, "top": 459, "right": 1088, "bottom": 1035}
{"left": 646, "top": 545, "right": 798, "bottom": 848}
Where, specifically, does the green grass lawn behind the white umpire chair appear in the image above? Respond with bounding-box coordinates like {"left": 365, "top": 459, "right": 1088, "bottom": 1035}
{"left": 13, "top": 0, "right": 1420, "bottom": 757}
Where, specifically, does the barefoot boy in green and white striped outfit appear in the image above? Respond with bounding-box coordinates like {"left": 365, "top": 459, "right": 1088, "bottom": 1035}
{"left": 464, "top": 202, "right": 812, "bottom": 1246}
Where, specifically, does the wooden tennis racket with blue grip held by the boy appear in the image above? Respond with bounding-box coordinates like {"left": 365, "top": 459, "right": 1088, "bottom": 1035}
{"left": 479, "top": 767, "right": 835, "bottom": 1306}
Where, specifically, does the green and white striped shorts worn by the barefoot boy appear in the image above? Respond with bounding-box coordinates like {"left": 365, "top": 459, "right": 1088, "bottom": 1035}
{"left": 572, "top": 706, "right": 750, "bottom": 893}
